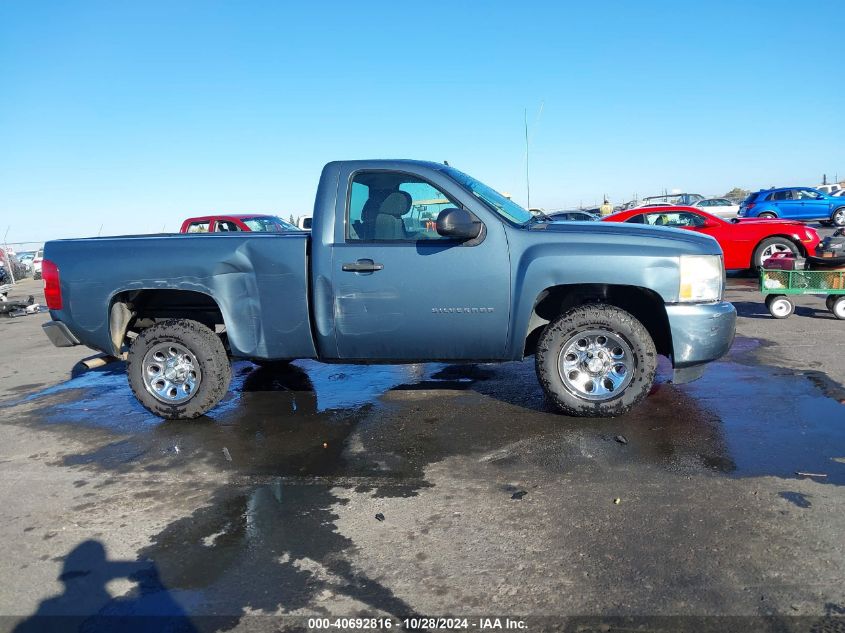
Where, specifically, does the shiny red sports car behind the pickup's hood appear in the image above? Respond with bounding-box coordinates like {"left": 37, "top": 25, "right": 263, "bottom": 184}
{"left": 602, "top": 207, "right": 819, "bottom": 270}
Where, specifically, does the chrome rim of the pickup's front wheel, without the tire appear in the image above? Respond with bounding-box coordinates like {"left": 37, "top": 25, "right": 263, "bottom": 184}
{"left": 558, "top": 329, "right": 635, "bottom": 401}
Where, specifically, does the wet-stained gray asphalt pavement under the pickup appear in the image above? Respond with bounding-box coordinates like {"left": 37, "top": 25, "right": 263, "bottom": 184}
{"left": 0, "top": 268, "right": 845, "bottom": 631}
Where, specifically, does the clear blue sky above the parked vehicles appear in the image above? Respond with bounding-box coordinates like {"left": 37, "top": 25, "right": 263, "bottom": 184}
{"left": 0, "top": 0, "right": 845, "bottom": 241}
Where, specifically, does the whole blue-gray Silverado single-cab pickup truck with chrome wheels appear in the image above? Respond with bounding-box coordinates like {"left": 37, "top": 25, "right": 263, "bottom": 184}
{"left": 42, "top": 160, "right": 736, "bottom": 418}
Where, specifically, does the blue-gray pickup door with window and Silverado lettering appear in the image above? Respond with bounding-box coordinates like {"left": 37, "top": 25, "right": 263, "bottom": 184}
{"left": 332, "top": 170, "right": 511, "bottom": 361}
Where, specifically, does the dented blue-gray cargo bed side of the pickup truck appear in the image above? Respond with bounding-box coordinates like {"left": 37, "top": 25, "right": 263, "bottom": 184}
{"left": 44, "top": 232, "right": 316, "bottom": 359}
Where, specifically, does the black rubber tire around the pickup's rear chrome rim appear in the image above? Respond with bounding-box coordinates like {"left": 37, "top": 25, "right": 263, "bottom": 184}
{"left": 126, "top": 319, "right": 232, "bottom": 420}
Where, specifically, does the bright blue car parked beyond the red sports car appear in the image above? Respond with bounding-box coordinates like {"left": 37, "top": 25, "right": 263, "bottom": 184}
{"left": 739, "top": 187, "right": 845, "bottom": 227}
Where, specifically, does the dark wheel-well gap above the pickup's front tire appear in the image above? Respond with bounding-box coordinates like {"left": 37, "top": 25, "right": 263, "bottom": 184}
{"left": 523, "top": 283, "right": 673, "bottom": 357}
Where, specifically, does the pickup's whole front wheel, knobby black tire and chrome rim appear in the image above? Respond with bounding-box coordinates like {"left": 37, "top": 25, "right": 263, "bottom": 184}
{"left": 535, "top": 304, "right": 657, "bottom": 417}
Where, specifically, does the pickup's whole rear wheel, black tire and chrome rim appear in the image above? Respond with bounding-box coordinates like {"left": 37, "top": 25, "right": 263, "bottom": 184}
{"left": 126, "top": 319, "right": 232, "bottom": 420}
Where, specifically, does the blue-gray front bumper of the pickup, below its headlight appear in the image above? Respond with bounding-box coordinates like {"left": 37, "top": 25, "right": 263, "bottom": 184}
{"left": 666, "top": 301, "right": 736, "bottom": 383}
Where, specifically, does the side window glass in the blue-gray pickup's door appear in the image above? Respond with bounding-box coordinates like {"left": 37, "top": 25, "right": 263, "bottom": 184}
{"left": 346, "top": 171, "right": 460, "bottom": 242}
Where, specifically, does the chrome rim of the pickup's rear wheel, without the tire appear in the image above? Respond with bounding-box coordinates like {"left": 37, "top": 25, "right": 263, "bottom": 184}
{"left": 142, "top": 343, "right": 202, "bottom": 404}
